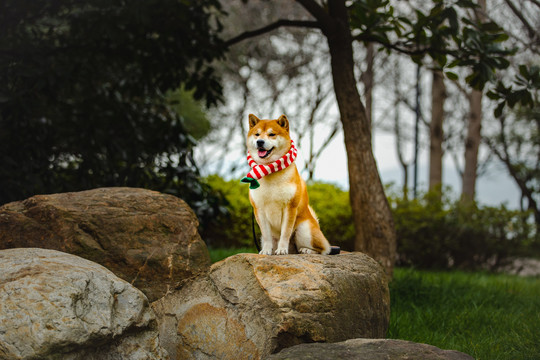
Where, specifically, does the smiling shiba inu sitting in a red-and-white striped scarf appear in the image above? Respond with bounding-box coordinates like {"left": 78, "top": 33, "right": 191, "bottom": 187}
{"left": 242, "top": 114, "right": 331, "bottom": 255}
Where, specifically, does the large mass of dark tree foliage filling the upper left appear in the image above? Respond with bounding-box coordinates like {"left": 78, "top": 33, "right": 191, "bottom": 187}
{"left": 0, "top": 0, "right": 223, "bottom": 217}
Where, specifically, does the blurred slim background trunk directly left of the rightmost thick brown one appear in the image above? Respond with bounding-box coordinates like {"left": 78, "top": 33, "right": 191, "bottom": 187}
{"left": 429, "top": 70, "right": 446, "bottom": 198}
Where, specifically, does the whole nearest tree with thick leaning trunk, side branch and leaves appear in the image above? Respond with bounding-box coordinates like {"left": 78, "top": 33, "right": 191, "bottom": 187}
{"left": 224, "top": 0, "right": 507, "bottom": 273}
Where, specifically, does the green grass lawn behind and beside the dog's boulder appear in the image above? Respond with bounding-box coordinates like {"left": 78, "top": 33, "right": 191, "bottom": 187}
{"left": 210, "top": 248, "right": 540, "bottom": 360}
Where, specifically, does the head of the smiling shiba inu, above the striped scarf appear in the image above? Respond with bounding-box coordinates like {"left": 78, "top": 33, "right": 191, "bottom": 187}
{"left": 247, "top": 114, "right": 291, "bottom": 164}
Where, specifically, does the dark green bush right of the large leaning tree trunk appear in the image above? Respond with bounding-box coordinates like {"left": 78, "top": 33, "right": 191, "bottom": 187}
{"left": 390, "top": 193, "right": 536, "bottom": 270}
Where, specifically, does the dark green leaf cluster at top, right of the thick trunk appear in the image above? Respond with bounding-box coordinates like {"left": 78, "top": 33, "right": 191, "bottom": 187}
{"left": 350, "top": 0, "right": 514, "bottom": 89}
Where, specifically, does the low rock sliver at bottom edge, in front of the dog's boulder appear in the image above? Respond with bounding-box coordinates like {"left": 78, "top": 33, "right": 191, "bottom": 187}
{"left": 267, "top": 339, "right": 474, "bottom": 360}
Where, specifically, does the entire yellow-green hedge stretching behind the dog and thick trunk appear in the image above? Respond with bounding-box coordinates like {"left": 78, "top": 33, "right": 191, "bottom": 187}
{"left": 202, "top": 176, "right": 540, "bottom": 270}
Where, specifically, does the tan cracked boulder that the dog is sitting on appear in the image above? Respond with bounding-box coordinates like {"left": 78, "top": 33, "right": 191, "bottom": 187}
{"left": 152, "top": 253, "right": 390, "bottom": 360}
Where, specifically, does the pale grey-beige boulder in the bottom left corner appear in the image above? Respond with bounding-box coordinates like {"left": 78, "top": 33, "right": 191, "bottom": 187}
{"left": 0, "top": 248, "right": 168, "bottom": 360}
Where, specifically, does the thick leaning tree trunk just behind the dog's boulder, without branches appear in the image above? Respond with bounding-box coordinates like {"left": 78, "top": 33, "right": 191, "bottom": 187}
{"left": 323, "top": 0, "right": 396, "bottom": 276}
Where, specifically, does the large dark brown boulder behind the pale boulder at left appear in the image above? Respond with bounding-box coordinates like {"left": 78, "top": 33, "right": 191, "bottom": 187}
{"left": 0, "top": 188, "right": 211, "bottom": 301}
